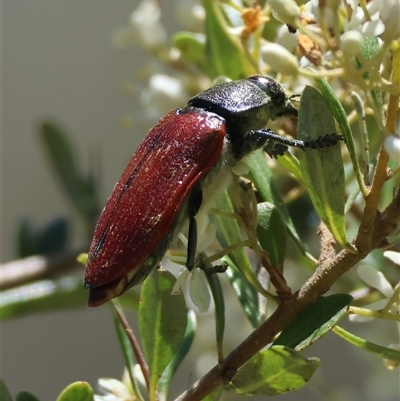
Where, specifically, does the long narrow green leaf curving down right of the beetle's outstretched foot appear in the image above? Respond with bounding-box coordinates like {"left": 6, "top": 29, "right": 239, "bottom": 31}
{"left": 314, "top": 78, "right": 367, "bottom": 194}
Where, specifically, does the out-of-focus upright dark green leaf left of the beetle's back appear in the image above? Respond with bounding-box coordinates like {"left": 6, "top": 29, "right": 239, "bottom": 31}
{"left": 40, "top": 121, "right": 101, "bottom": 233}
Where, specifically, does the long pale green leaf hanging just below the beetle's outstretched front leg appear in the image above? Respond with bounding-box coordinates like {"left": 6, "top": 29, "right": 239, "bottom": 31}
{"left": 246, "top": 151, "right": 305, "bottom": 254}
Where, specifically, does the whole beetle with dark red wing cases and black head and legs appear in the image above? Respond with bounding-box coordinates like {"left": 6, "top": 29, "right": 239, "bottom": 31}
{"left": 84, "top": 75, "right": 341, "bottom": 306}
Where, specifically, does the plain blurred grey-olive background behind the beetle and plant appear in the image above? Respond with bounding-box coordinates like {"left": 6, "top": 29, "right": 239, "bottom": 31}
{"left": 0, "top": 0, "right": 398, "bottom": 401}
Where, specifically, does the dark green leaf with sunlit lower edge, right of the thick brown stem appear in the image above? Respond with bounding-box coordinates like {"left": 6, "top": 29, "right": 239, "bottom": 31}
{"left": 273, "top": 294, "right": 353, "bottom": 351}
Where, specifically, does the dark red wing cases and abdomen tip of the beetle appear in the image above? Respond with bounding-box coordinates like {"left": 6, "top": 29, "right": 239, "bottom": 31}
{"left": 84, "top": 108, "right": 226, "bottom": 306}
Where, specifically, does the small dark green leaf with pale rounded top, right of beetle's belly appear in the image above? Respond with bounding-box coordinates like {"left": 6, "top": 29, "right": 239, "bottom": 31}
{"left": 257, "top": 202, "right": 286, "bottom": 273}
